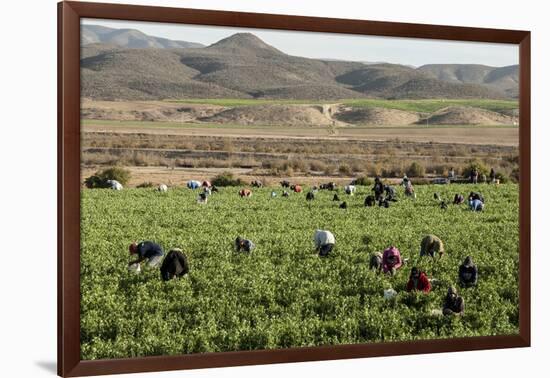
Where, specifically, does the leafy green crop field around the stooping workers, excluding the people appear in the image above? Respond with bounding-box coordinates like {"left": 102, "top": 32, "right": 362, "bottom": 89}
{"left": 81, "top": 184, "right": 519, "bottom": 360}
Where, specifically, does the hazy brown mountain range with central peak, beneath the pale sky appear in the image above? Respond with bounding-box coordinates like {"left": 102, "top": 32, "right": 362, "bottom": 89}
{"left": 81, "top": 25, "right": 518, "bottom": 100}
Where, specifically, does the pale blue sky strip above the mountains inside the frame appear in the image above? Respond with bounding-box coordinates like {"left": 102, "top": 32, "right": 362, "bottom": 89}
{"left": 83, "top": 19, "right": 519, "bottom": 67}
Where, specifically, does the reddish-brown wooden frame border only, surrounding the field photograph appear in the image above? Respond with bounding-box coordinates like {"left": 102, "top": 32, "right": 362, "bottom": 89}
{"left": 58, "top": 2, "right": 531, "bottom": 377}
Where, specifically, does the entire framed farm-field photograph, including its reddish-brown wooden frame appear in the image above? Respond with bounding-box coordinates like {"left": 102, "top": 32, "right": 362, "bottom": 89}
{"left": 58, "top": 2, "right": 530, "bottom": 376}
